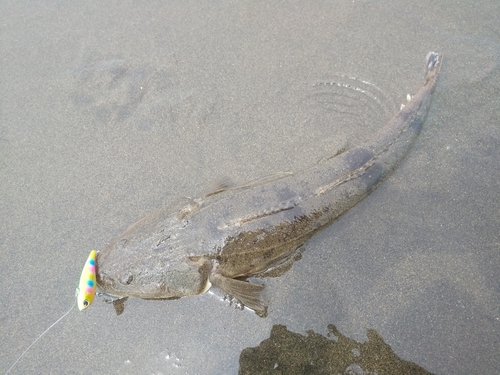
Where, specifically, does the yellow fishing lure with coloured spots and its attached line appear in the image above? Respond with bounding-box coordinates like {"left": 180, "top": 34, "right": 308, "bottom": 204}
{"left": 5, "top": 250, "right": 96, "bottom": 375}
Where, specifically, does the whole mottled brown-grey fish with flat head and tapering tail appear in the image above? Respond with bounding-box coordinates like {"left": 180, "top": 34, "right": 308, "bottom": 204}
{"left": 97, "top": 52, "right": 442, "bottom": 316}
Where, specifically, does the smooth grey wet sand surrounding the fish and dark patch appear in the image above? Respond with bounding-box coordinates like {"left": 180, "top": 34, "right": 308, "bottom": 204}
{"left": 0, "top": 1, "right": 500, "bottom": 374}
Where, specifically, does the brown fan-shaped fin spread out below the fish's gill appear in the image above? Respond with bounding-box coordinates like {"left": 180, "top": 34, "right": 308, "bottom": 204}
{"left": 210, "top": 271, "right": 267, "bottom": 318}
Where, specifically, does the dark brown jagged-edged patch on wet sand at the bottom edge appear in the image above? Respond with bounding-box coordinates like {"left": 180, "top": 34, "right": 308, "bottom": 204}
{"left": 238, "top": 324, "right": 430, "bottom": 375}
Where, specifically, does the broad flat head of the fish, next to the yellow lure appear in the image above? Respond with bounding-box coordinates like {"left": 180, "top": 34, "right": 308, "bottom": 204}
{"left": 96, "top": 200, "right": 212, "bottom": 299}
